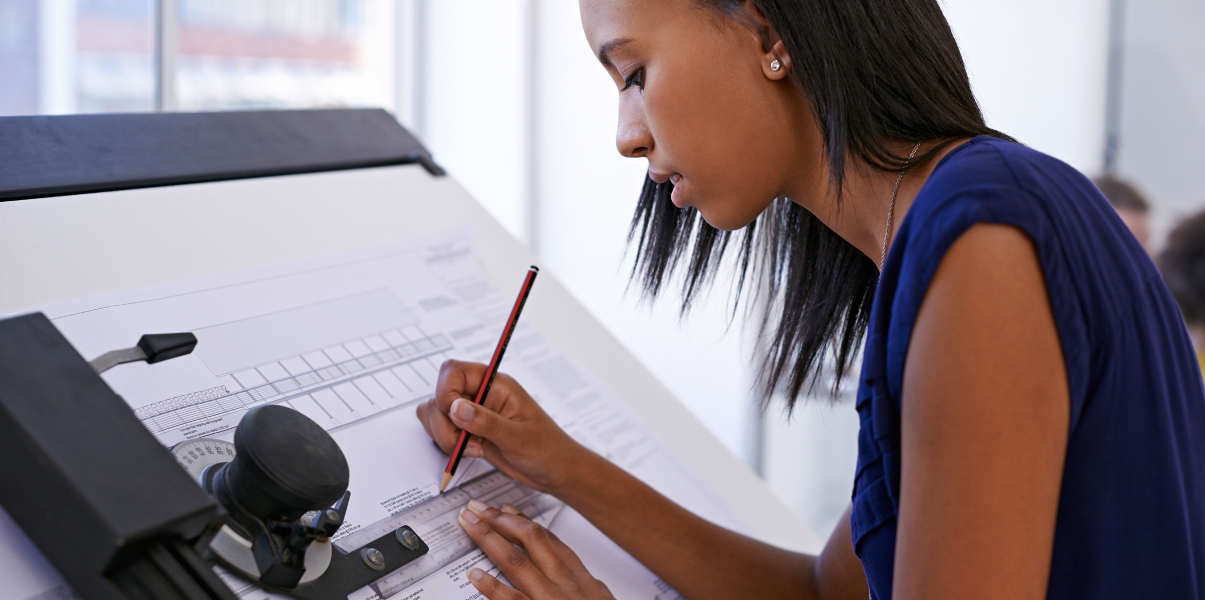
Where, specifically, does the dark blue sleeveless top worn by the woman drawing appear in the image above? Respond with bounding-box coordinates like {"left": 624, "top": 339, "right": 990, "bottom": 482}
{"left": 851, "top": 136, "right": 1205, "bottom": 600}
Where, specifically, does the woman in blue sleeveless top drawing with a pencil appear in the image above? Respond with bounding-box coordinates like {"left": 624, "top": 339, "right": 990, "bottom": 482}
{"left": 418, "top": 0, "right": 1205, "bottom": 600}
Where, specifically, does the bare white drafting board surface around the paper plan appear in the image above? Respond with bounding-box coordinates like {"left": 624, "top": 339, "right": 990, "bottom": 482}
{"left": 0, "top": 166, "right": 822, "bottom": 551}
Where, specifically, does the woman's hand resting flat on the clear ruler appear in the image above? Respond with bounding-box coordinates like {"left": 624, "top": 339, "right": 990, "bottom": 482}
{"left": 460, "top": 500, "right": 615, "bottom": 600}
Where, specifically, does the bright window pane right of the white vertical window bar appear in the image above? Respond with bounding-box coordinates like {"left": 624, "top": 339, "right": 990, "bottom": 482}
{"left": 176, "top": 0, "right": 396, "bottom": 111}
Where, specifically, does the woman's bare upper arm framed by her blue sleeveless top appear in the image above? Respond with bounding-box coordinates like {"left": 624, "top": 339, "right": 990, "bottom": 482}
{"left": 894, "top": 225, "right": 1070, "bottom": 600}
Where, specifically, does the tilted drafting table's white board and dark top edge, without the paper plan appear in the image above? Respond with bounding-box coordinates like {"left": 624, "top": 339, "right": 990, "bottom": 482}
{"left": 0, "top": 110, "right": 821, "bottom": 595}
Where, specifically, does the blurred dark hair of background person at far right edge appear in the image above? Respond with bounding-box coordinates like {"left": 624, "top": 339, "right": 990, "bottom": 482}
{"left": 1159, "top": 212, "right": 1205, "bottom": 325}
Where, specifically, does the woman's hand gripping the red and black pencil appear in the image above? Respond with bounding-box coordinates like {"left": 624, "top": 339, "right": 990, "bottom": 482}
{"left": 417, "top": 360, "right": 589, "bottom": 494}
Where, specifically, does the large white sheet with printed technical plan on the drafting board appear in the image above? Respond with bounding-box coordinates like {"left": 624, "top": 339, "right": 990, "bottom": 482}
{"left": 0, "top": 233, "right": 740, "bottom": 600}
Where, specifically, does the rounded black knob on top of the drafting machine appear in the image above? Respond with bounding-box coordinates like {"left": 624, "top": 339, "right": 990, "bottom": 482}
{"left": 213, "top": 405, "right": 349, "bottom": 520}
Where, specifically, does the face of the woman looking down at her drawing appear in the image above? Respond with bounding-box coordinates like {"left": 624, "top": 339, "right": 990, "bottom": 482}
{"left": 580, "top": 0, "right": 803, "bottom": 229}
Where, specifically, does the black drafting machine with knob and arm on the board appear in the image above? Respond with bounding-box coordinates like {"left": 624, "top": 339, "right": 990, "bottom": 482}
{"left": 0, "top": 313, "right": 428, "bottom": 600}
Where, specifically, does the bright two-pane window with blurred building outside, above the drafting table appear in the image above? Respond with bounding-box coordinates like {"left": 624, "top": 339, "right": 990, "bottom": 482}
{"left": 0, "top": 0, "right": 404, "bottom": 116}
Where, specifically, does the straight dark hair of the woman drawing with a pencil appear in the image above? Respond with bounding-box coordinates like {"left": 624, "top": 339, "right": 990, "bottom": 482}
{"left": 628, "top": 0, "right": 1009, "bottom": 408}
